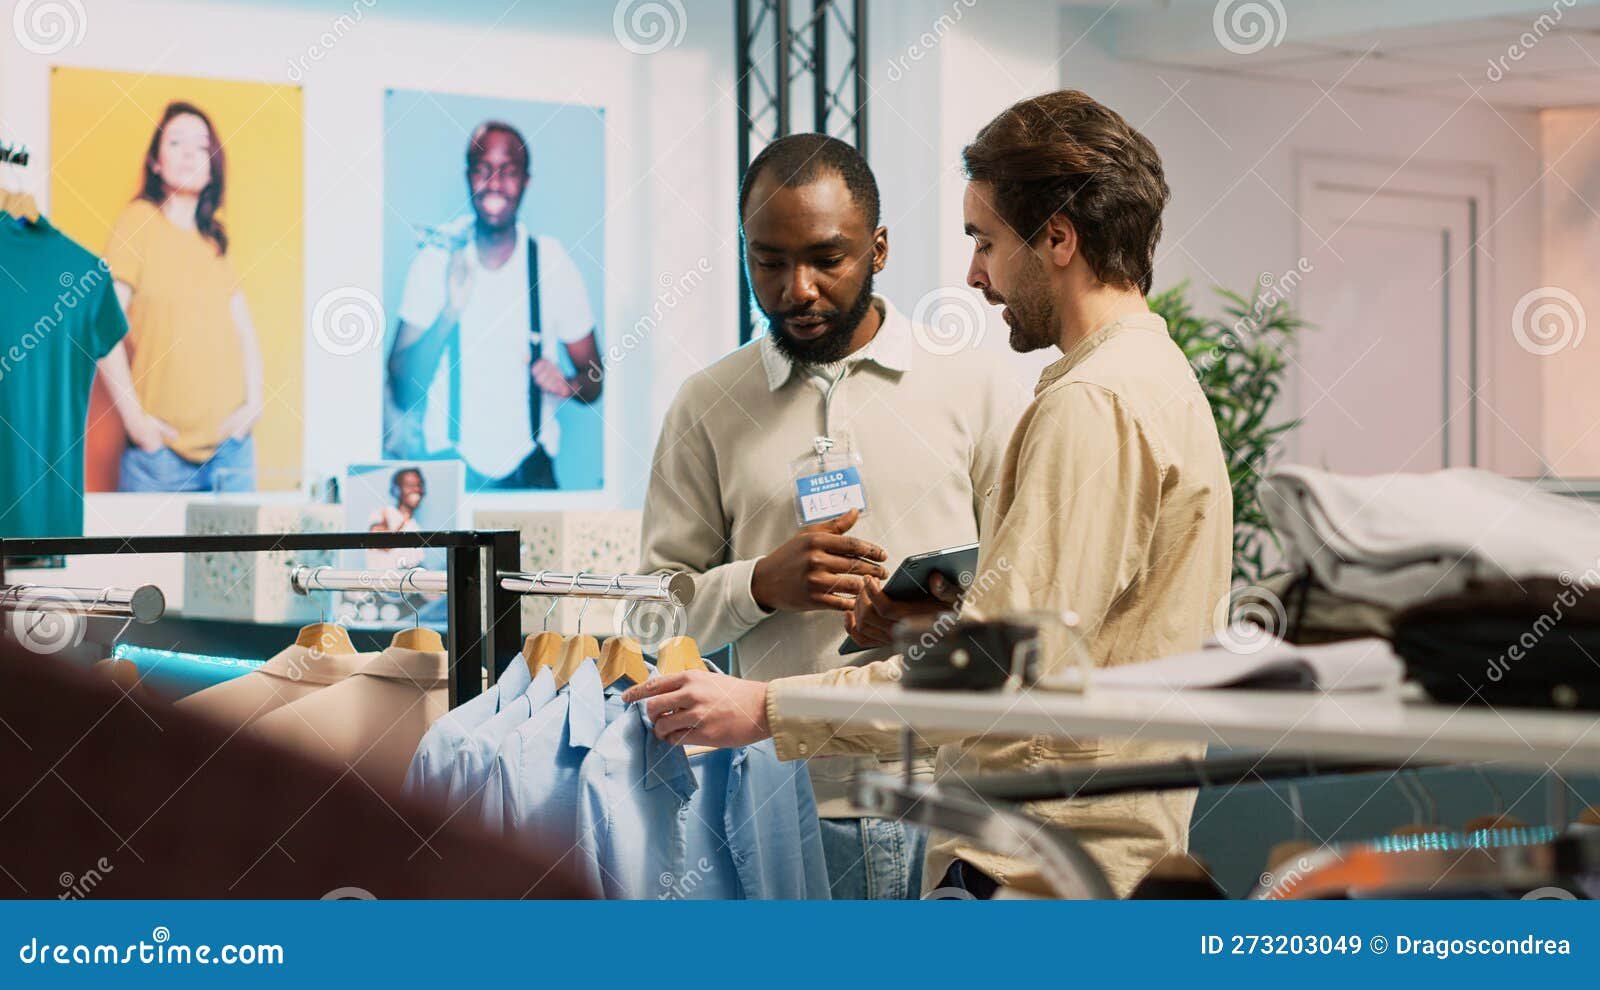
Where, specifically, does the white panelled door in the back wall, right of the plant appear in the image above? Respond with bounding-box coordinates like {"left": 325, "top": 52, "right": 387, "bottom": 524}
{"left": 1291, "top": 166, "right": 1483, "bottom": 473}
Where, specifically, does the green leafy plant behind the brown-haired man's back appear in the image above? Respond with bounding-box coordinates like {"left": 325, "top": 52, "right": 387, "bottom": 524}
{"left": 1150, "top": 281, "right": 1309, "bottom": 585}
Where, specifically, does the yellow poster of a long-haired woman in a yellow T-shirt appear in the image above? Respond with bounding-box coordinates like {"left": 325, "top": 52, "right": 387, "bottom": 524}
{"left": 50, "top": 66, "right": 306, "bottom": 491}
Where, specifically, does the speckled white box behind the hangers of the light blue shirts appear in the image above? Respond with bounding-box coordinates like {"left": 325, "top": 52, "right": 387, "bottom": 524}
{"left": 472, "top": 509, "right": 646, "bottom": 638}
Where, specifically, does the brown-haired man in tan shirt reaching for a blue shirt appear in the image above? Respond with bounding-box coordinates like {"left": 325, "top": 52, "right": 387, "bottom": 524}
{"left": 627, "top": 91, "right": 1232, "bottom": 896}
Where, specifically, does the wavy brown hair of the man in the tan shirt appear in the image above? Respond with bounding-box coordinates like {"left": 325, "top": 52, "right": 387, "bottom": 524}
{"left": 962, "top": 90, "right": 1170, "bottom": 294}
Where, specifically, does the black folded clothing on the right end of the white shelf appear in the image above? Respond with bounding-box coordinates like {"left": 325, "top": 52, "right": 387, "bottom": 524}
{"left": 1394, "top": 582, "right": 1600, "bottom": 710}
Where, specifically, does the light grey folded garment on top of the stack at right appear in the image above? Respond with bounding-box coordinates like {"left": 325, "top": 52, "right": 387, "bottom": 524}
{"left": 1259, "top": 465, "right": 1600, "bottom": 608}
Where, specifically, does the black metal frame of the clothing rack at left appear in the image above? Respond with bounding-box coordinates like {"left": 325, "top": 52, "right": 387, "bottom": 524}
{"left": 0, "top": 529, "right": 522, "bottom": 707}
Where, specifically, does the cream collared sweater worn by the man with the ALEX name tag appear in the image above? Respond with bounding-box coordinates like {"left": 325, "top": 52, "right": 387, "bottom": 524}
{"left": 642, "top": 297, "right": 1027, "bottom": 817}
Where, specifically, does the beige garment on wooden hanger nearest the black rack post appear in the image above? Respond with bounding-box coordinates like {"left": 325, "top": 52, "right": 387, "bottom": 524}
{"left": 250, "top": 646, "right": 450, "bottom": 793}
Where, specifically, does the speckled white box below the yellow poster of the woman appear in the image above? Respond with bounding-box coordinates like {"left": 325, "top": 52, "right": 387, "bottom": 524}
{"left": 184, "top": 502, "right": 346, "bottom": 622}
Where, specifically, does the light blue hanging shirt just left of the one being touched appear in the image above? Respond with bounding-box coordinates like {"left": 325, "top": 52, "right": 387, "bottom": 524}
{"left": 482, "top": 661, "right": 634, "bottom": 856}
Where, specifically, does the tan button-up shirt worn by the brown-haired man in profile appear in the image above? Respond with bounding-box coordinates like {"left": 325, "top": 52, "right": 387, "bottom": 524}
{"left": 768, "top": 315, "right": 1234, "bottom": 896}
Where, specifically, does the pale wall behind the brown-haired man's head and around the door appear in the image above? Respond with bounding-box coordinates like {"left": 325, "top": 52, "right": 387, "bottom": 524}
{"left": 875, "top": 0, "right": 1542, "bottom": 473}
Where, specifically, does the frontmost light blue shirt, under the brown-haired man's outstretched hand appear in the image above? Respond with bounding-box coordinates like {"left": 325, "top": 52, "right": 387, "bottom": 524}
{"left": 578, "top": 704, "right": 829, "bottom": 900}
